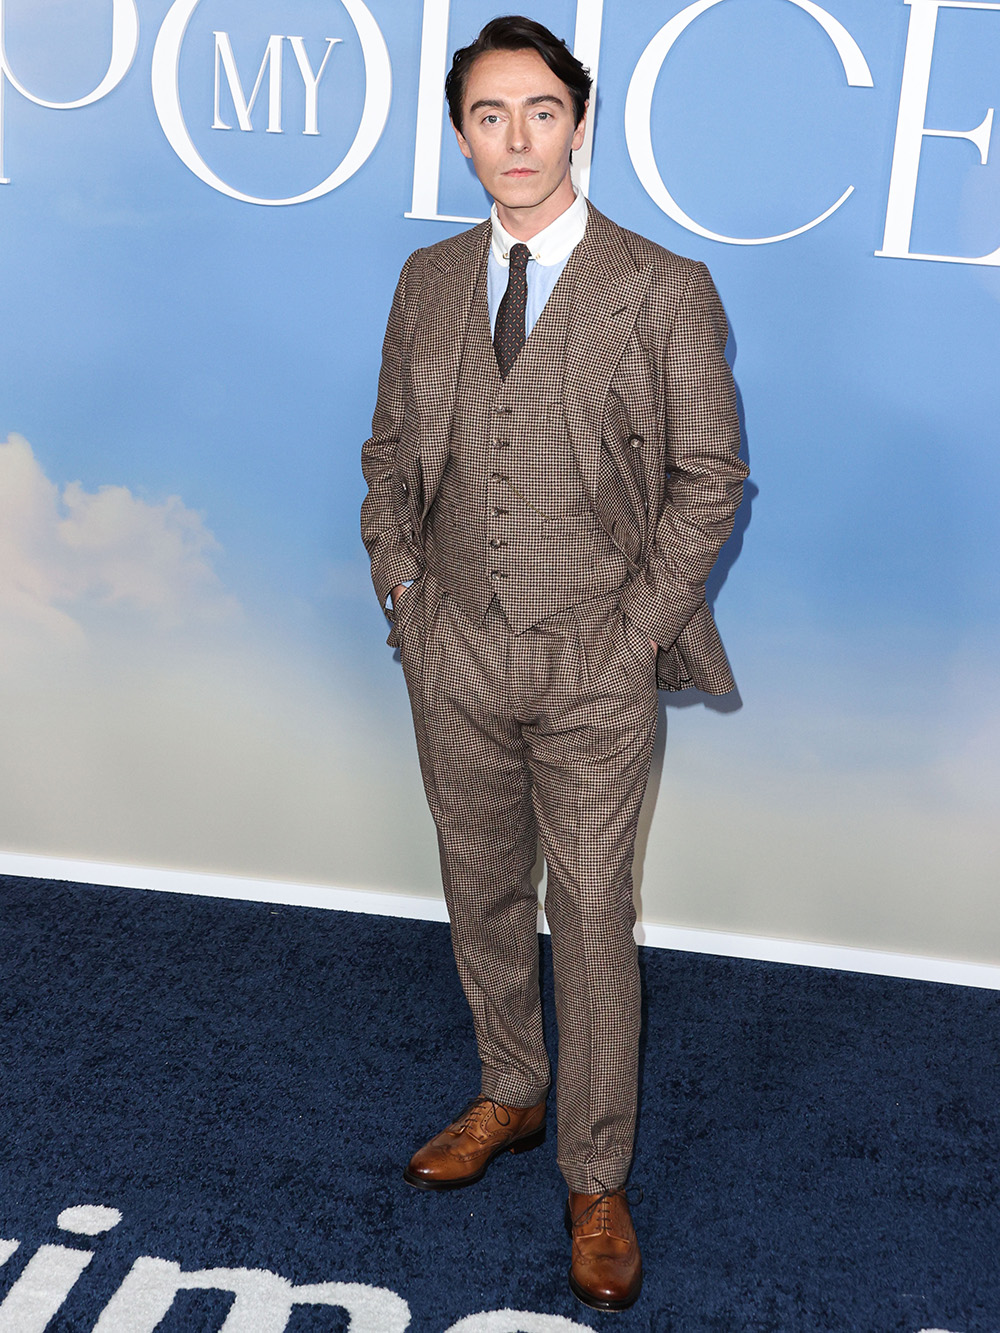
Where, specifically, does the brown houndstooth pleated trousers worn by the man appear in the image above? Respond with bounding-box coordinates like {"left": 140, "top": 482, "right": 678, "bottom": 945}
{"left": 400, "top": 573, "right": 656, "bottom": 1193}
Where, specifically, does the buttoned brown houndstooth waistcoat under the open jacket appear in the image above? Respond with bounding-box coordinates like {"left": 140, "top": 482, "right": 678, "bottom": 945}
{"left": 425, "top": 260, "right": 629, "bottom": 633}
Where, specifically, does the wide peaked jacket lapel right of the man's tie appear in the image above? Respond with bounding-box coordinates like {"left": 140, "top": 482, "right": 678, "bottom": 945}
{"left": 564, "top": 204, "right": 652, "bottom": 503}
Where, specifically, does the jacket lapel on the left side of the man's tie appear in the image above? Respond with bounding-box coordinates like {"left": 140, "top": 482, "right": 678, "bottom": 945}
{"left": 411, "top": 221, "right": 491, "bottom": 519}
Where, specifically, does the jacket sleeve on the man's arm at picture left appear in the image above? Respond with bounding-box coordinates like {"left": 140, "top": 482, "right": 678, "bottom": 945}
{"left": 361, "top": 255, "right": 424, "bottom": 620}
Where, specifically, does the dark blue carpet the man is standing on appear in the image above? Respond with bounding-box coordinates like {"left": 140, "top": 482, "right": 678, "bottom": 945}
{"left": 0, "top": 878, "right": 1000, "bottom": 1333}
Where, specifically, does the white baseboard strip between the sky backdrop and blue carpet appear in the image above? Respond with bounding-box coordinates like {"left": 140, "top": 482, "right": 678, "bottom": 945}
{"left": 0, "top": 852, "right": 1000, "bottom": 990}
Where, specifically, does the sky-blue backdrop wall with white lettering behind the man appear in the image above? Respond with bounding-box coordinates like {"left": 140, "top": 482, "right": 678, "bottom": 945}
{"left": 0, "top": 0, "right": 1000, "bottom": 962}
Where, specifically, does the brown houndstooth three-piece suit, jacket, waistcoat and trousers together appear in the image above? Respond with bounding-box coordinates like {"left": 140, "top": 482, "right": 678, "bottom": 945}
{"left": 361, "top": 199, "right": 747, "bottom": 1193}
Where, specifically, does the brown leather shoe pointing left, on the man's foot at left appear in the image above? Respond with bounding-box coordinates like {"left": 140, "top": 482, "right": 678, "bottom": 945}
{"left": 403, "top": 1097, "right": 545, "bottom": 1189}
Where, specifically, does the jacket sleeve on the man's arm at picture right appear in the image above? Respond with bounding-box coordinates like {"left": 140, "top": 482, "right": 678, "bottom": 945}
{"left": 621, "top": 263, "right": 749, "bottom": 648}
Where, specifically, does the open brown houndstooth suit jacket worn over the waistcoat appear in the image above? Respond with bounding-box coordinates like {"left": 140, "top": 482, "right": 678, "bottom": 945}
{"left": 361, "top": 204, "right": 748, "bottom": 694}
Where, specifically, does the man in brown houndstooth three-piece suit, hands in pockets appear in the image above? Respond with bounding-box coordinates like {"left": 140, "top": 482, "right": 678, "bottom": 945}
{"left": 361, "top": 17, "right": 747, "bottom": 1310}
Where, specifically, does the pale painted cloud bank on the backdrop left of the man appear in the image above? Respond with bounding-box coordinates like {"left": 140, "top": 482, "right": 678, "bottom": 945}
{"left": 0, "top": 436, "right": 436, "bottom": 892}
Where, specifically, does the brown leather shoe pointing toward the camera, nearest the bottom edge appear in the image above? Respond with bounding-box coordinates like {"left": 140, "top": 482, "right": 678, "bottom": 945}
{"left": 565, "top": 1189, "right": 643, "bottom": 1310}
